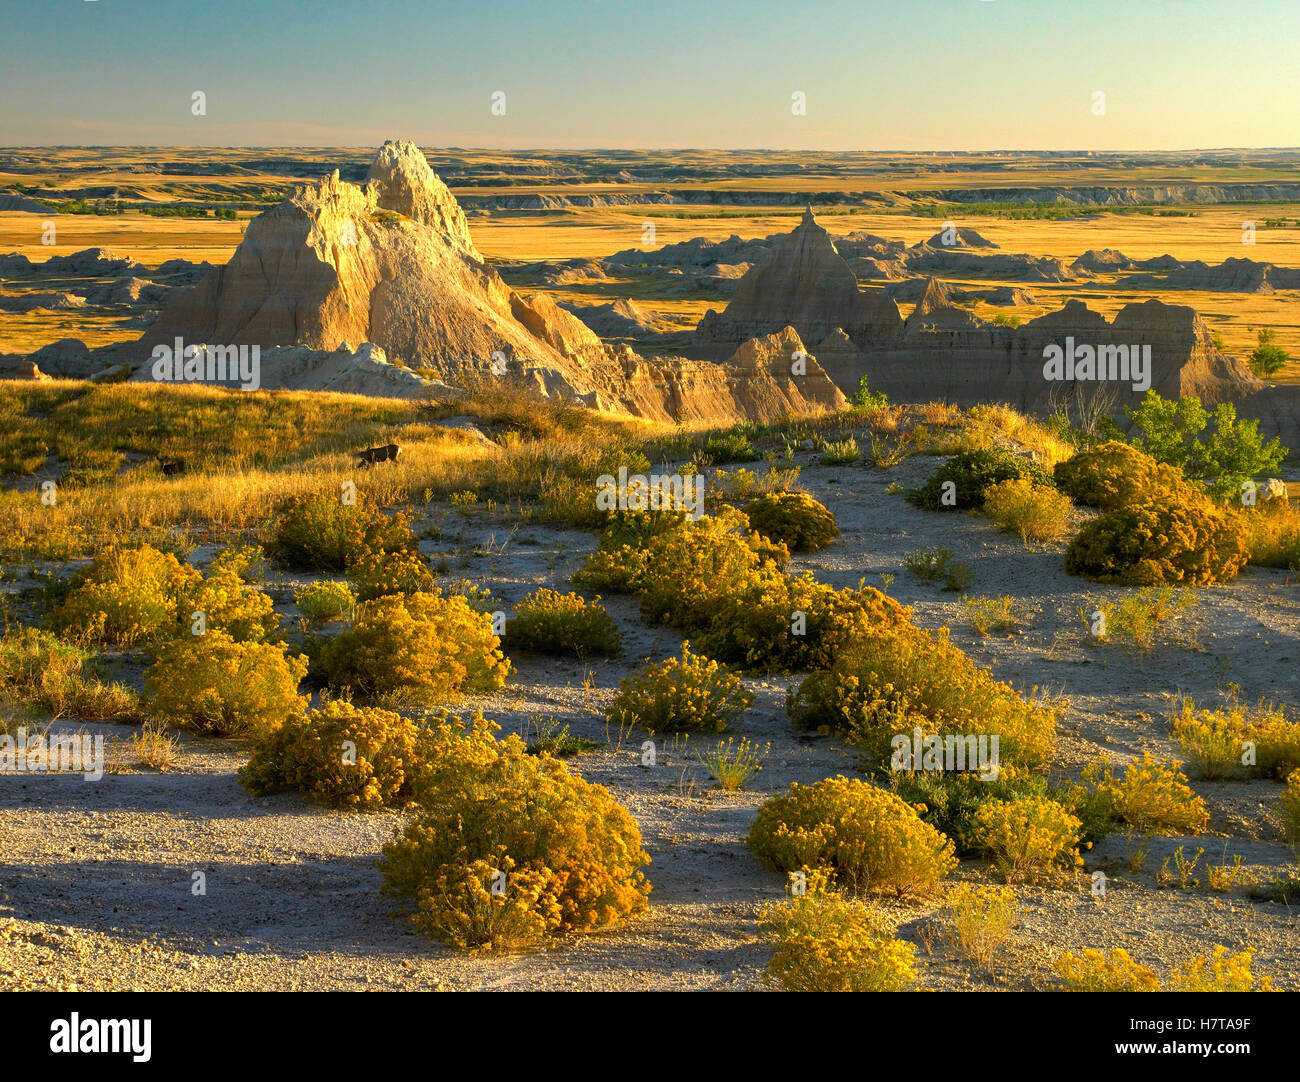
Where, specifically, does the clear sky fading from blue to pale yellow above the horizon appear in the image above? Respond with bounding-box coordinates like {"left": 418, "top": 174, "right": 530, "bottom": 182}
{"left": 0, "top": 0, "right": 1300, "bottom": 151}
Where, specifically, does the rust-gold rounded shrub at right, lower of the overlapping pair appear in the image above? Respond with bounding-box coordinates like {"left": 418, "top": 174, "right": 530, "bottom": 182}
{"left": 1065, "top": 495, "right": 1247, "bottom": 587}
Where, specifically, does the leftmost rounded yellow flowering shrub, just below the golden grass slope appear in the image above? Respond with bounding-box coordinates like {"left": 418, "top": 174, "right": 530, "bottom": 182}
{"left": 51, "top": 545, "right": 203, "bottom": 648}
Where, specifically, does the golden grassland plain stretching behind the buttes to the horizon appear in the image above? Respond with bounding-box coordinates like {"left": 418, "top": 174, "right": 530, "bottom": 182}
{"left": 0, "top": 148, "right": 1300, "bottom": 371}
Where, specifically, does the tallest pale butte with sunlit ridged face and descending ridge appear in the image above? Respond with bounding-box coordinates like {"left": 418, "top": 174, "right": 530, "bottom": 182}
{"left": 78, "top": 142, "right": 852, "bottom": 423}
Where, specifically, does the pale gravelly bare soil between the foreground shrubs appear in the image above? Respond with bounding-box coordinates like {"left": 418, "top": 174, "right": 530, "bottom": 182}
{"left": 0, "top": 455, "right": 1300, "bottom": 990}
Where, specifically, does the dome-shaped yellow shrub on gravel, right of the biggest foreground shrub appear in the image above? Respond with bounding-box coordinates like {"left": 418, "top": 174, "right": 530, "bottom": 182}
{"left": 749, "top": 776, "right": 957, "bottom": 896}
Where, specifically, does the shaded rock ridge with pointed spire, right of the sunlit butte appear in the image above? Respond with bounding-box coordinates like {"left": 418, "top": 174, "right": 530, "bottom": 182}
{"left": 692, "top": 216, "right": 1274, "bottom": 429}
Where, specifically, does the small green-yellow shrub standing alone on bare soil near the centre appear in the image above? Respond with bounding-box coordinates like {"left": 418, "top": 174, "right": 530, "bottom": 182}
{"left": 608, "top": 642, "right": 754, "bottom": 732}
